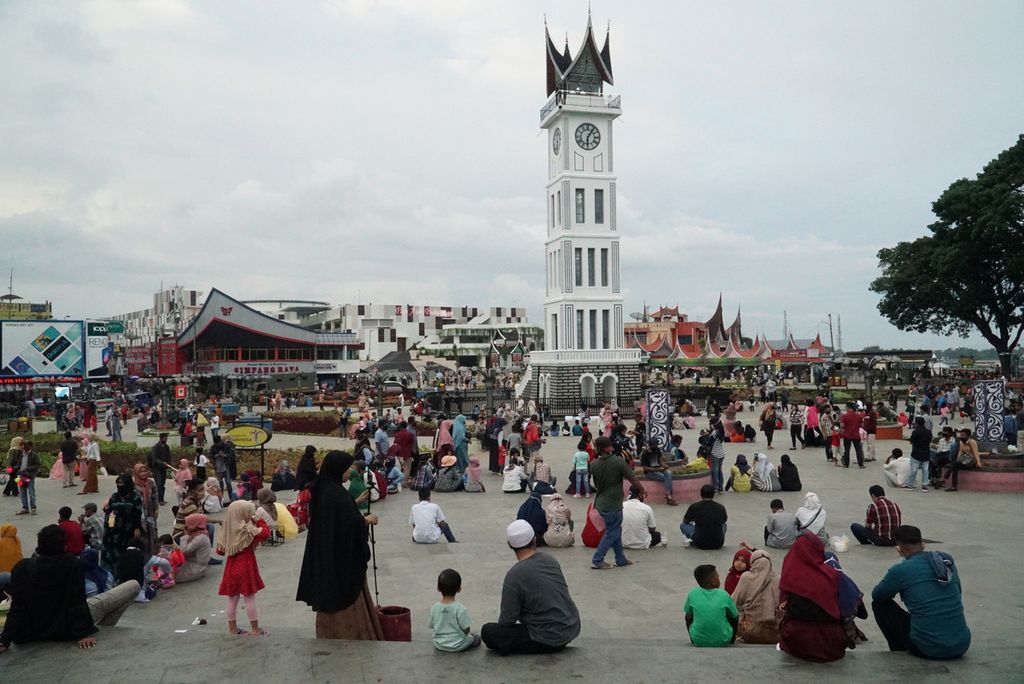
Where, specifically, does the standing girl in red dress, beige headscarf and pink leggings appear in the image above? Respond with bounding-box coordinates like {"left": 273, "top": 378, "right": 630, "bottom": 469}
{"left": 217, "top": 499, "right": 270, "bottom": 636}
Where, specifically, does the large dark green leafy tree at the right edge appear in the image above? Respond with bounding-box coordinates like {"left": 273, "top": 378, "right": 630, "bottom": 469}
{"left": 870, "top": 135, "right": 1024, "bottom": 378}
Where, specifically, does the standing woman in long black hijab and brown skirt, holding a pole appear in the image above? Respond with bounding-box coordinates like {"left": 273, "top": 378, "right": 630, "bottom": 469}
{"left": 295, "top": 452, "right": 383, "bottom": 641}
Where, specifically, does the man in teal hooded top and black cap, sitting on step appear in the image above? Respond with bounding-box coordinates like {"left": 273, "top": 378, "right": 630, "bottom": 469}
{"left": 871, "top": 525, "right": 971, "bottom": 659}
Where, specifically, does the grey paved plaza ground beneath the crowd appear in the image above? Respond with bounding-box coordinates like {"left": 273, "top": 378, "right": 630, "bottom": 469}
{"left": 0, "top": 419, "right": 1024, "bottom": 682}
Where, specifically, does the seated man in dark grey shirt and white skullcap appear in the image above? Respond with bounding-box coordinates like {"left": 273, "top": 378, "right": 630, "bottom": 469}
{"left": 480, "top": 520, "right": 580, "bottom": 655}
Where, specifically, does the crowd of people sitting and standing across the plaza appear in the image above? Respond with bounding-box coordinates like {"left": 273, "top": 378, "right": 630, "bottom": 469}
{"left": 0, "top": 387, "right": 991, "bottom": 661}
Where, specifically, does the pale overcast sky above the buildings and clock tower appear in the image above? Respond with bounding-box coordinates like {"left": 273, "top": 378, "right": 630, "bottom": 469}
{"left": 0, "top": 0, "right": 1024, "bottom": 349}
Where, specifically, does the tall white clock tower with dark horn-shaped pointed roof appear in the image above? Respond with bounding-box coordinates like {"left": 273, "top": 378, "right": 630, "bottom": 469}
{"left": 520, "top": 16, "right": 640, "bottom": 415}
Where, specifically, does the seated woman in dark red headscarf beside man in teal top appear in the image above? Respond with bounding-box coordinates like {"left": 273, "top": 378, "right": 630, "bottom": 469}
{"left": 778, "top": 532, "right": 866, "bottom": 662}
